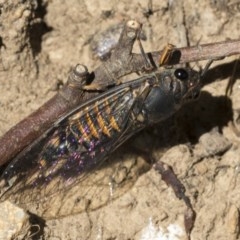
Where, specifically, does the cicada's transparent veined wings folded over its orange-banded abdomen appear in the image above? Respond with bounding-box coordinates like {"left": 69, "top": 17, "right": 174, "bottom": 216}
{"left": 0, "top": 82, "right": 150, "bottom": 218}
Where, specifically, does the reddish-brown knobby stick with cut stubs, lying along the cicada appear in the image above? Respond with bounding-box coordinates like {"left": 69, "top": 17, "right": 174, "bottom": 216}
{"left": 0, "top": 20, "right": 240, "bottom": 166}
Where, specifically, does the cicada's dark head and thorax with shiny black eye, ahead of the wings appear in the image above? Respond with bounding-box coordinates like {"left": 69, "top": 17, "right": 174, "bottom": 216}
{"left": 143, "top": 68, "right": 200, "bottom": 123}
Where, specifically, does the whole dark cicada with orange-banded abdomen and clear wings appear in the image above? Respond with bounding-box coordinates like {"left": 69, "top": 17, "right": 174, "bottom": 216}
{"left": 0, "top": 68, "right": 200, "bottom": 217}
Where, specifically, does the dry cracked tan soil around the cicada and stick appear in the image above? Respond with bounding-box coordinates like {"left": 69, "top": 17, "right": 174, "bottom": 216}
{"left": 0, "top": 0, "right": 240, "bottom": 240}
